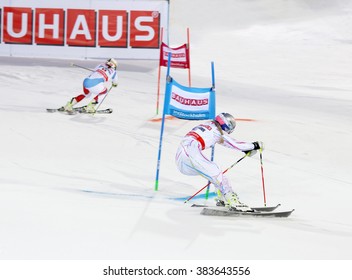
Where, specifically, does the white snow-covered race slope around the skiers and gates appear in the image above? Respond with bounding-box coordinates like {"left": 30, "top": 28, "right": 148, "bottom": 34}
{"left": 0, "top": 0, "right": 352, "bottom": 260}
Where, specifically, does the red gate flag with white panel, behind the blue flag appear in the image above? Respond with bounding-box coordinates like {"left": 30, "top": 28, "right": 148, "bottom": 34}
{"left": 159, "top": 43, "right": 190, "bottom": 69}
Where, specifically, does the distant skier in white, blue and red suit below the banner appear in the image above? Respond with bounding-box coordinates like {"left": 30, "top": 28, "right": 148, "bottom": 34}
{"left": 59, "top": 58, "right": 118, "bottom": 113}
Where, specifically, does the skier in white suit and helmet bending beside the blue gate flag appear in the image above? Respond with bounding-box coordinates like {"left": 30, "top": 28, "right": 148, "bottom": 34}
{"left": 175, "top": 113, "right": 263, "bottom": 211}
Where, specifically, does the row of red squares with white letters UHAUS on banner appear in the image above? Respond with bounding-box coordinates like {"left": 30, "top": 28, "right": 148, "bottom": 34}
{"left": 1, "top": 7, "right": 160, "bottom": 48}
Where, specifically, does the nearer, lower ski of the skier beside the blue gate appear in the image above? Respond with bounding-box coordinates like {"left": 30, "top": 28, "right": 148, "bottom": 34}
{"left": 200, "top": 207, "right": 294, "bottom": 218}
